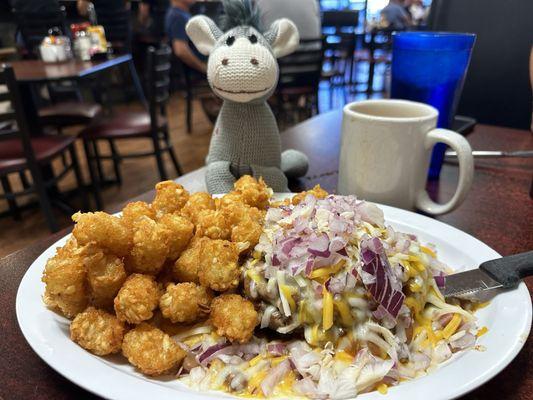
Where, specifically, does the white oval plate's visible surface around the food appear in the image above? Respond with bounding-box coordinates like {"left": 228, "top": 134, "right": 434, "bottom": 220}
{"left": 16, "top": 196, "right": 531, "bottom": 400}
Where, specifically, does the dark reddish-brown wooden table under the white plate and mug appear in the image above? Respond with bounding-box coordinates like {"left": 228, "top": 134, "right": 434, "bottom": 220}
{"left": 0, "top": 112, "right": 533, "bottom": 400}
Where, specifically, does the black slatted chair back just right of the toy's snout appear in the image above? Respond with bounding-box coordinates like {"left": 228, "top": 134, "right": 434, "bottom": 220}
{"left": 278, "top": 39, "right": 324, "bottom": 92}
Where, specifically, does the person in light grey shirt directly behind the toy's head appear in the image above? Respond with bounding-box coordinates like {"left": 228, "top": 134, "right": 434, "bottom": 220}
{"left": 255, "top": 0, "right": 322, "bottom": 44}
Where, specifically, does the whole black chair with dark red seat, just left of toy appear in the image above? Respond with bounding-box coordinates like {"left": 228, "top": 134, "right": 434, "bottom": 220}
{"left": 81, "top": 45, "right": 182, "bottom": 204}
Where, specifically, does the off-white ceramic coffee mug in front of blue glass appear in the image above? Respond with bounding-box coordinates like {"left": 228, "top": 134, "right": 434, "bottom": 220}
{"left": 338, "top": 100, "right": 474, "bottom": 215}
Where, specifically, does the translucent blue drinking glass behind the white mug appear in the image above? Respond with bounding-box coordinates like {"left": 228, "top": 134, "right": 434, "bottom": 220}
{"left": 391, "top": 32, "right": 476, "bottom": 179}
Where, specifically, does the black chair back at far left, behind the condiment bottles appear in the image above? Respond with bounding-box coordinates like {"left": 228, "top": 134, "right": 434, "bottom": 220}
{"left": 14, "top": 7, "right": 70, "bottom": 57}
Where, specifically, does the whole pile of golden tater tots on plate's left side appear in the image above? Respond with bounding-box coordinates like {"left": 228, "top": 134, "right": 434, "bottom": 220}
{"left": 42, "top": 176, "right": 272, "bottom": 376}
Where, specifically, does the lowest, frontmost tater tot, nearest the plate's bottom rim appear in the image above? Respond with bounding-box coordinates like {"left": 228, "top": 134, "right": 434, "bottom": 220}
{"left": 122, "top": 323, "right": 186, "bottom": 376}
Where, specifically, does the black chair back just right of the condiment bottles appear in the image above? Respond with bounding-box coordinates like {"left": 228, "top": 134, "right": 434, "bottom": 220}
{"left": 96, "top": 7, "right": 132, "bottom": 54}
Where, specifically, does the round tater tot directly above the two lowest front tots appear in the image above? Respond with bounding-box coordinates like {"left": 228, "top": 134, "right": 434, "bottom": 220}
{"left": 114, "top": 274, "right": 161, "bottom": 324}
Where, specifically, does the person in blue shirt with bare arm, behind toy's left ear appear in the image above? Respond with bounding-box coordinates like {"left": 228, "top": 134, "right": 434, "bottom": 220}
{"left": 165, "top": 0, "right": 207, "bottom": 75}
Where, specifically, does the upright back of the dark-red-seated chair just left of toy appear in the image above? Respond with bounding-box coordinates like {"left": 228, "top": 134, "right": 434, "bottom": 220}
{"left": 147, "top": 44, "right": 172, "bottom": 128}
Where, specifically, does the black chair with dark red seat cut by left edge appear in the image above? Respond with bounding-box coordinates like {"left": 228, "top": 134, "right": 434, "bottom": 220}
{"left": 0, "top": 65, "right": 89, "bottom": 232}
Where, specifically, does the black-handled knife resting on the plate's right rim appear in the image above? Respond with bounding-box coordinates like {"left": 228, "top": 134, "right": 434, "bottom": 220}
{"left": 442, "top": 251, "right": 533, "bottom": 302}
